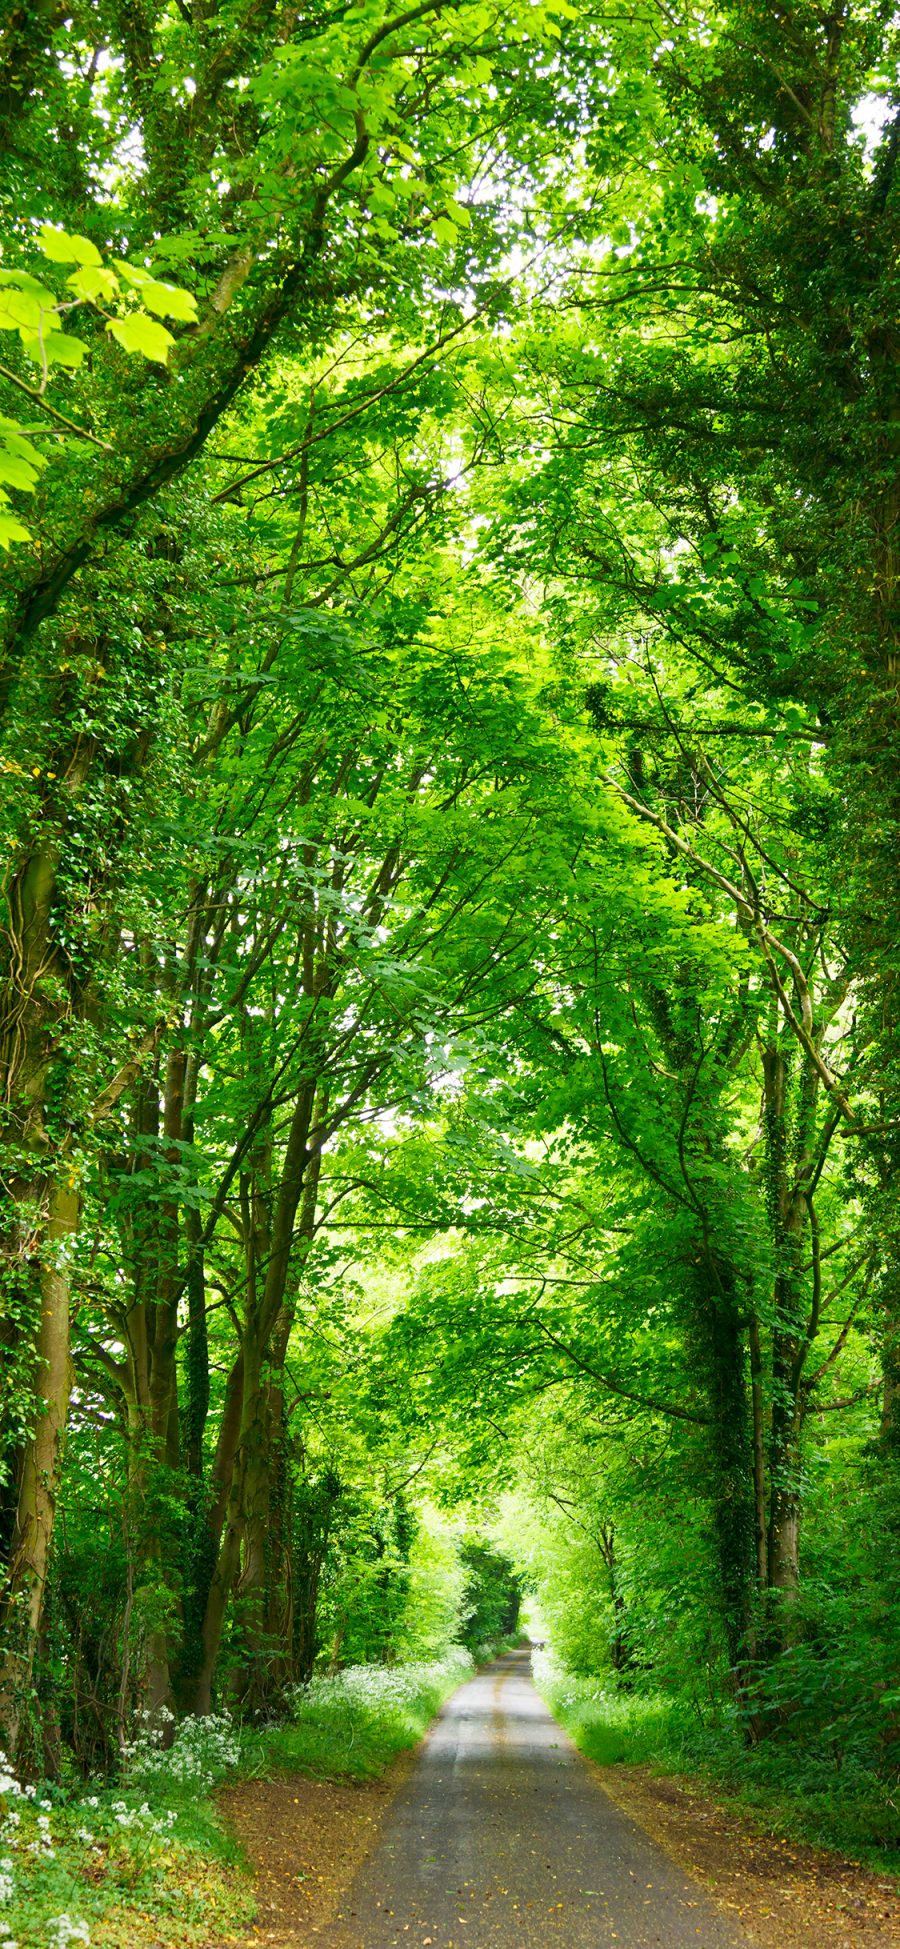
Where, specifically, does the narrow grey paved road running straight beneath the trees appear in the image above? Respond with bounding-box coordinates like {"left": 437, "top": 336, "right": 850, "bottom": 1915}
{"left": 327, "top": 1653, "right": 750, "bottom": 1949}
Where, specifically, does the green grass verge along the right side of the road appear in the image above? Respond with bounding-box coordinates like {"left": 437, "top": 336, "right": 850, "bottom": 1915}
{"left": 534, "top": 1653, "right": 900, "bottom": 1873}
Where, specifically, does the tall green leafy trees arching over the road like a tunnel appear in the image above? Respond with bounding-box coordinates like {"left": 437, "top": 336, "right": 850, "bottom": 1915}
{"left": 0, "top": 0, "right": 900, "bottom": 1830}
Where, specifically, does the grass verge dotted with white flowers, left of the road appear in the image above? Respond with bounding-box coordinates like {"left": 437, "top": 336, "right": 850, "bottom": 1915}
{"left": 0, "top": 1645, "right": 473, "bottom": 1949}
